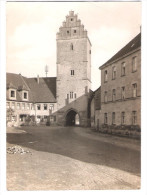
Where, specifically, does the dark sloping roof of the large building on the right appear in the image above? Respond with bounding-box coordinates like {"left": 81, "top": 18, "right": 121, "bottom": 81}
{"left": 99, "top": 33, "right": 141, "bottom": 69}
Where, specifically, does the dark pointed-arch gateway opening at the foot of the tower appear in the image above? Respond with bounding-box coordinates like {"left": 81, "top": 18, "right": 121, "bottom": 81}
{"left": 66, "top": 110, "right": 80, "bottom": 126}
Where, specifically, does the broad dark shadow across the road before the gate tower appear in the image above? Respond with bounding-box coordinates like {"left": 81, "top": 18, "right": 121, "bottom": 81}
{"left": 7, "top": 127, "right": 140, "bottom": 175}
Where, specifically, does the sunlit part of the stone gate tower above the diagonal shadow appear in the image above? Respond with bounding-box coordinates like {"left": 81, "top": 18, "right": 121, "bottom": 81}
{"left": 56, "top": 11, "right": 91, "bottom": 126}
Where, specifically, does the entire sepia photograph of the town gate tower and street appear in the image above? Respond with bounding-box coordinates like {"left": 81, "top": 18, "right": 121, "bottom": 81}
{"left": 0, "top": 1, "right": 146, "bottom": 193}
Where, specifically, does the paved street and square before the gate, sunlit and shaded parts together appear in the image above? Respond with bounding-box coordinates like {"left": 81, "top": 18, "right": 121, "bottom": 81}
{"left": 7, "top": 127, "right": 140, "bottom": 190}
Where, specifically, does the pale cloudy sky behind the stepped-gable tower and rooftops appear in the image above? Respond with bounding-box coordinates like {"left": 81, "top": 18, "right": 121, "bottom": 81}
{"left": 6, "top": 2, "right": 141, "bottom": 90}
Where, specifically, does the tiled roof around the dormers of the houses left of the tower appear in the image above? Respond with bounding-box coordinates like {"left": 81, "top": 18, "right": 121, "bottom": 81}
{"left": 7, "top": 73, "right": 56, "bottom": 103}
